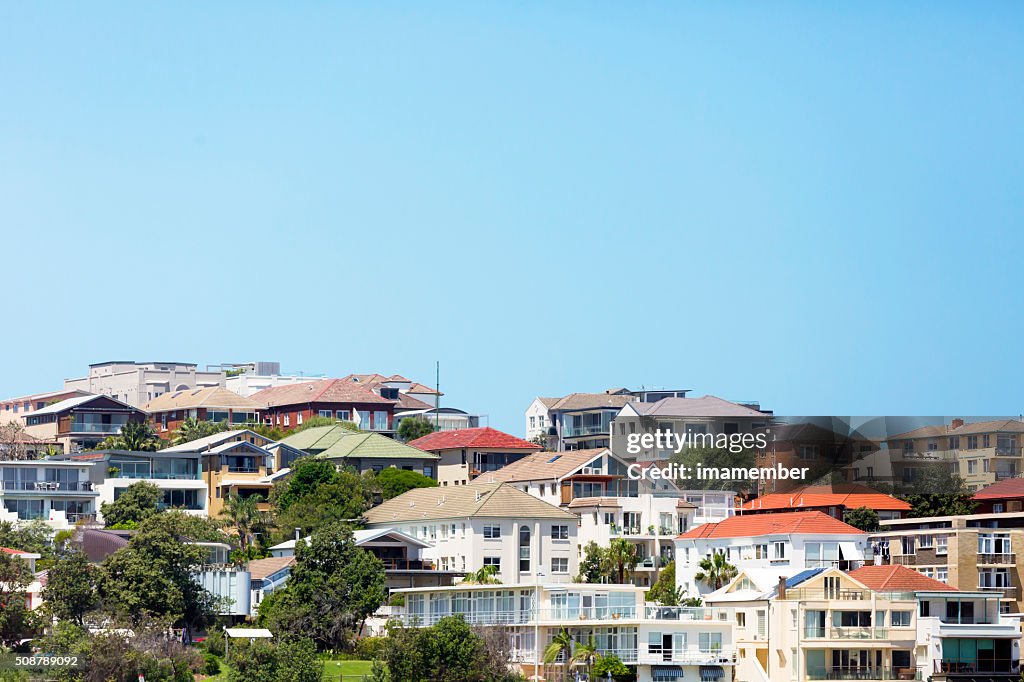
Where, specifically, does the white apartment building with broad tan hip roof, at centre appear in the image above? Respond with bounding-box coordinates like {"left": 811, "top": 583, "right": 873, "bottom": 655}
{"left": 366, "top": 483, "right": 579, "bottom": 584}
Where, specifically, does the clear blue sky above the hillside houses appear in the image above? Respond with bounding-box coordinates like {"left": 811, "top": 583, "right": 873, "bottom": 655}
{"left": 0, "top": 2, "right": 1024, "bottom": 433}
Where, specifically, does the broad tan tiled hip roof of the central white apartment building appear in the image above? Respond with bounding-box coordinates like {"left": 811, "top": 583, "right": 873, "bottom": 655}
{"left": 365, "top": 483, "right": 580, "bottom": 523}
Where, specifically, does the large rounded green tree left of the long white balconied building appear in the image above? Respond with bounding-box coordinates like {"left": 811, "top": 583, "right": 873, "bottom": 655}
{"left": 259, "top": 524, "right": 386, "bottom": 649}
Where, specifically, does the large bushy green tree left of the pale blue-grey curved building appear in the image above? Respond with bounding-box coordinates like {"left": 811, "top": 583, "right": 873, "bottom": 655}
{"left": 97, "top": 510, "right": 223, "bottom": 631}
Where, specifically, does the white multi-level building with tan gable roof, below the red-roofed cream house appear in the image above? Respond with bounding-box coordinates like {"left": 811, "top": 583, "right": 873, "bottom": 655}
{"left": 478, "top": 447, "right": 733, "bottom": 586}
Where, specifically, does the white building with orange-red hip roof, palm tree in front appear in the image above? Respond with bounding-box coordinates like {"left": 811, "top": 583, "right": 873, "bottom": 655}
{"left": 676, "top": 511, "right": 871, "bottom": 596}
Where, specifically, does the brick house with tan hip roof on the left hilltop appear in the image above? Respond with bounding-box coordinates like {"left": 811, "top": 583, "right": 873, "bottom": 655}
{"left": 142, "top": 386, "right": 260, "bottom": 438}
